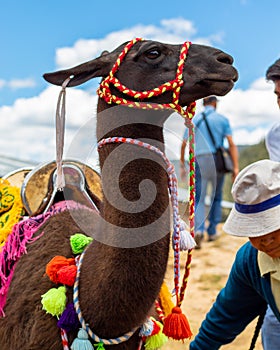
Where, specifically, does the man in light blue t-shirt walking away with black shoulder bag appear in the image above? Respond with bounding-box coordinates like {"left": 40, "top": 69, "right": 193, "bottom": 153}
{"left": 180, "top": 96, "right": 239, "bottom": 249}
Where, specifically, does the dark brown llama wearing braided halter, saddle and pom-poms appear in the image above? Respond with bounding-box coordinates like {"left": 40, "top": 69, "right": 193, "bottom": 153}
{"left": 0, "top": 40, "right": 237, "bottom": 350}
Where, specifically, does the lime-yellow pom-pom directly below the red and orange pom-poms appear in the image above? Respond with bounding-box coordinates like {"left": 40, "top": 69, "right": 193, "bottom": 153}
{"left": 41, "top": 286, "right": 66, "bottom": 317}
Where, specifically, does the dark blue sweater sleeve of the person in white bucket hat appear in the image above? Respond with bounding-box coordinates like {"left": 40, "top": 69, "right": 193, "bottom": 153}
{"left": 190, "top": 243, "right": 267, "bottom": 350}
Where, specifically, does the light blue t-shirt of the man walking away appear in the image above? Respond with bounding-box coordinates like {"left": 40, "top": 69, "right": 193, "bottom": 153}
{"left": 183, "top": 106, "right": 232, "bottom": 156}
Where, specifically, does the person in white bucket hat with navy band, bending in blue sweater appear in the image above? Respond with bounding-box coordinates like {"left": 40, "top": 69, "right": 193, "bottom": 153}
{"left": 190, "top": 159, "right": 280, "bottom": 350}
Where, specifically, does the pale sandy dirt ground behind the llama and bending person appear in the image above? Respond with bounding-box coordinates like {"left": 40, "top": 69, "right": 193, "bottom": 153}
{"left": 162, "top": 227, "right": 263, "bottom": 350}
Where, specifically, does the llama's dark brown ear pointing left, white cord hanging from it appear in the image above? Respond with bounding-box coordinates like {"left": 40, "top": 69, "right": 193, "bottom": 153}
{"left": 43, "top": 51, "right": 117, "bottom": 87}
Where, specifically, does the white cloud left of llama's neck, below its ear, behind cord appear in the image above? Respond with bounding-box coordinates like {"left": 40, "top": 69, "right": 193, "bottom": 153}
{"left": 0, "top": 86, "right": 97, "bottom": 162}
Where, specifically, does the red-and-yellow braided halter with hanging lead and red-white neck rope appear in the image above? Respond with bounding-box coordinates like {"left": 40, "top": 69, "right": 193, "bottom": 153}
{"left": 97, "top": 38, "right": 196, "bottom": 306}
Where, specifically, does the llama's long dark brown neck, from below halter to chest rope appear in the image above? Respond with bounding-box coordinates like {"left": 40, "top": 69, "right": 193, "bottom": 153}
{"left": 77, "top": 103, "right": 170, "bottom": 337}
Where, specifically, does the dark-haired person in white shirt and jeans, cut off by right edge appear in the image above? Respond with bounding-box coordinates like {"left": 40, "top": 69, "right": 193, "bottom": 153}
{"left": 261, "top": 59, "right": 280, "bottom": 350}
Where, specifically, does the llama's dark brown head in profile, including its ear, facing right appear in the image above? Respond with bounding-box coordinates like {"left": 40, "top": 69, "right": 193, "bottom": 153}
{"left": 44, "top": 40, "right": 238, "bottom": 106}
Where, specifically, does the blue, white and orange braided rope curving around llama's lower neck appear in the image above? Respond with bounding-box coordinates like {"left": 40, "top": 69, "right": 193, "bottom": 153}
{"left": 73, "top": 250, "right": 138, "bottom": 345}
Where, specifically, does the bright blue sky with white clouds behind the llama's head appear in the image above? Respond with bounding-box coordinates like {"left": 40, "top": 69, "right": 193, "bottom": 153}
{"left": 0, "top": 0, "right": 280, "bottom": 161}
